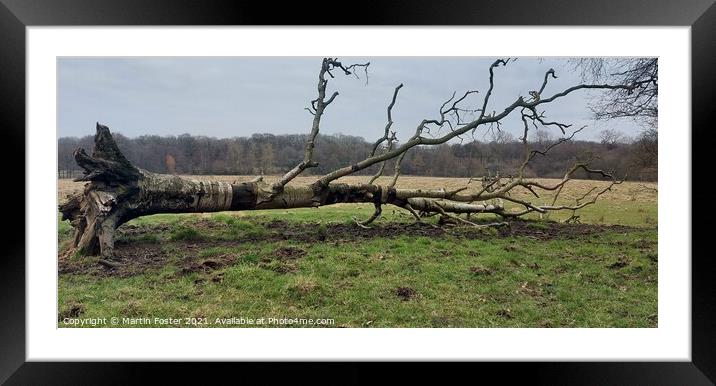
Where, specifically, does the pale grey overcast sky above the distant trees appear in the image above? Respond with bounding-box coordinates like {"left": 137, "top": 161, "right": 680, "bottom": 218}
{"left": 57, "top": 57, "right": 642, "bottom": 140}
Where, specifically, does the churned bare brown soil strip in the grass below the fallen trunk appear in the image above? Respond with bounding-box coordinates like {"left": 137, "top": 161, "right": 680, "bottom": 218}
{"left": 59, "top": 220, "right": 648, "bottom": 277}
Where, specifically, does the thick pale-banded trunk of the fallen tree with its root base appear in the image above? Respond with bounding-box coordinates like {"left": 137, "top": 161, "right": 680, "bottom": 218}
{"left": 60, "top": 124, "right": 502, "bottom": 259}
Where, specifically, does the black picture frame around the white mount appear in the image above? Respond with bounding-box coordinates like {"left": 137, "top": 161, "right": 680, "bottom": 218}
{"left": 0, "top": 0, "right": 716, "bottom": 384}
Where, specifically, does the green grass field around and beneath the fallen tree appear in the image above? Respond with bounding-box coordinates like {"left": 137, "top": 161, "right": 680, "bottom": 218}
{"left": 58, "top": 176, "right": 658, "bottom": 327}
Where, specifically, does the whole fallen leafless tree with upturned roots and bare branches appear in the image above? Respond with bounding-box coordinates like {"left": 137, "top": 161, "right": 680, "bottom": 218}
{"left": 60, "top": 58, "right": 641, "bottom": 260}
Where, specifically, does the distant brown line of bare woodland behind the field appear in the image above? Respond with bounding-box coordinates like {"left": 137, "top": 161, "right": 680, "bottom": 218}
{"left": 58, "top": 129, "right": 658, "bottom": 181}
